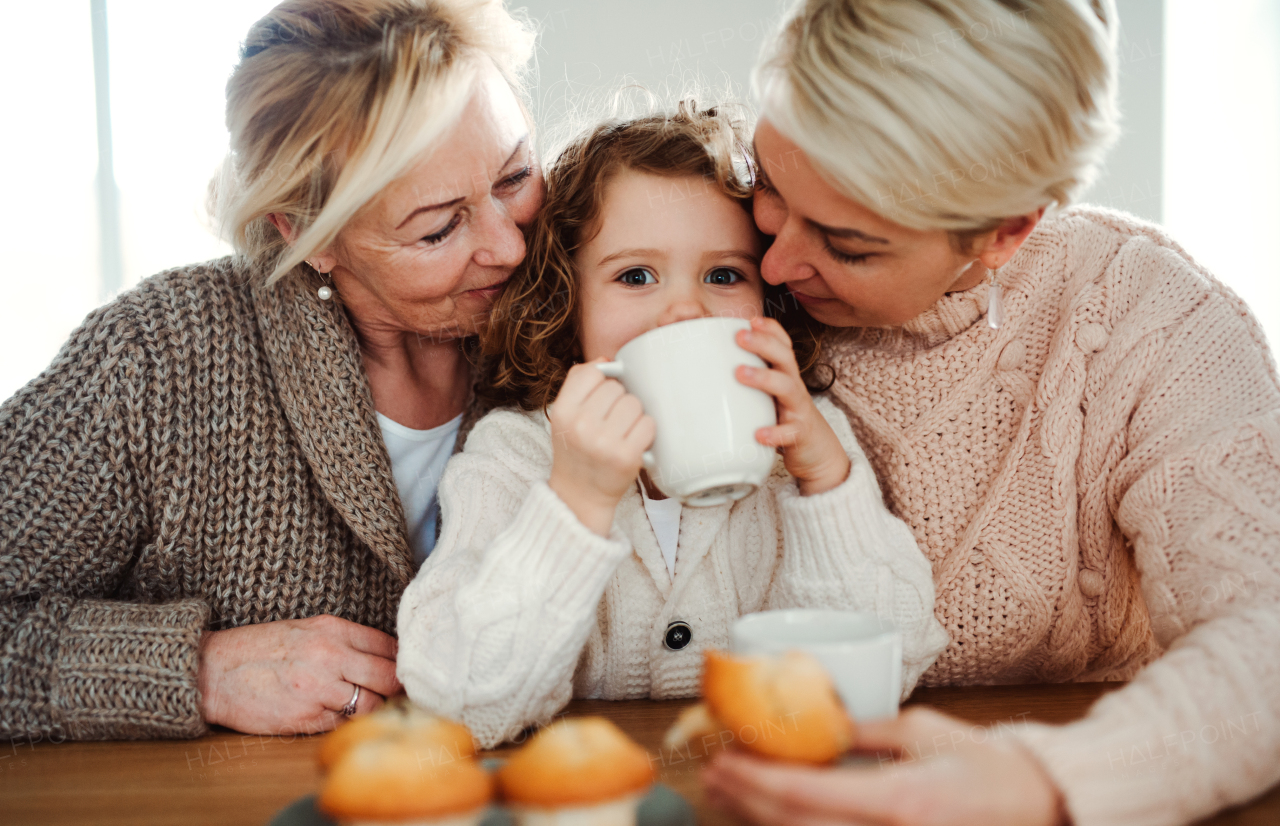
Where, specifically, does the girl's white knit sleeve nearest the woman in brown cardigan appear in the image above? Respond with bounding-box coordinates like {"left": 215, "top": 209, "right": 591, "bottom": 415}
{"left": 397, "top": 410, "right": 631, "bottom": 748}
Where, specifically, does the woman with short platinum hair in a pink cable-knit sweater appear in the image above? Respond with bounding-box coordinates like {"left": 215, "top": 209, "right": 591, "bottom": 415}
{"left": 707, "top": 0, "right": 1280, "bottom": 826}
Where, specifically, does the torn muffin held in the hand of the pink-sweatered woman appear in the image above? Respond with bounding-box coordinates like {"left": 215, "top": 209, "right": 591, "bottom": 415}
{"left": 663, "top": 651, "right": 855, "bottom": 765}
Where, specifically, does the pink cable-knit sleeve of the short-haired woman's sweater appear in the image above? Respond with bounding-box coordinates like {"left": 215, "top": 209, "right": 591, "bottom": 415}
{"left": 1021, "top": 245, "right": 1280, "bottom": 826}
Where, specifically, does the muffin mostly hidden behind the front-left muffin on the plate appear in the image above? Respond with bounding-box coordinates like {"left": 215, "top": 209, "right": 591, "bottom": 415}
{"left": 319, "top": 698, "right": 476, "bottom": 770}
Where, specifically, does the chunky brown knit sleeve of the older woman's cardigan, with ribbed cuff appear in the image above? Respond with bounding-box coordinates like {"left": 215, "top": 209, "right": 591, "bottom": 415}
{"left": 0, "top": 300, "right": 209, "bottom": 740}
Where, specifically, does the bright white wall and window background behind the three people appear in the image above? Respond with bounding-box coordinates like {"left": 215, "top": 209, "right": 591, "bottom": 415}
{"left": 0, "top": 0, "right": 1280, "bottom": 400}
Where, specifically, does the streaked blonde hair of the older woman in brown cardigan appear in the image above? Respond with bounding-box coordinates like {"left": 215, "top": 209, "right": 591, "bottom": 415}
{"left": 211, "top": 0, "right": 534, "bottom": 283}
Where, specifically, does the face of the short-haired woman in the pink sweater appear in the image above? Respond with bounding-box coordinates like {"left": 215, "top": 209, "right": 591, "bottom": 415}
{"left": 754, "top": 119, "right": 1008, "bottom": 327}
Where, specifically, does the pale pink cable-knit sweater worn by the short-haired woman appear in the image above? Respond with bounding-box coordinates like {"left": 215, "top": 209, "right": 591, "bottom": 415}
{"left": 832, "top": 207, "right": 1280, "bottom": 826}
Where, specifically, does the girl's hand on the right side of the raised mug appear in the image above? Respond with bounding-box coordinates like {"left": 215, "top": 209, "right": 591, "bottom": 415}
{"left": 736, "top": 316, "right": 850, "bottom": 496}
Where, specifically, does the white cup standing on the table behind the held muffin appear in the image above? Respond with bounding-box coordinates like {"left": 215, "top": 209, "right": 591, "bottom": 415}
{"left": 730, "top": 608, "right": 902, "bottom": 721}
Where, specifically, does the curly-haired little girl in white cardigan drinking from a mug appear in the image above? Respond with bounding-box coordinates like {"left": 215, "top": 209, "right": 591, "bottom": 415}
{"left": 397, "top": 105, "right": 948, "bottom": 748}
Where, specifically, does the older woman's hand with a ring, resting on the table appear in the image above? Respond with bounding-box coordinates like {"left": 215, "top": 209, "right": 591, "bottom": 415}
{"left": 198, "top": 616, "right": 403, "bottom": 734}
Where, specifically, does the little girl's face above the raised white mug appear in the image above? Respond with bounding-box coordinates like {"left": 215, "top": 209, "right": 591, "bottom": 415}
{"left": 573, "top": 169, "right": 764, "bottom": 361}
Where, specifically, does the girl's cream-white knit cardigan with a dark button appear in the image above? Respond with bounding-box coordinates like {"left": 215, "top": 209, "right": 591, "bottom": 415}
{"left": 397, "top": 397, "right": 948, "bottom": 748}
